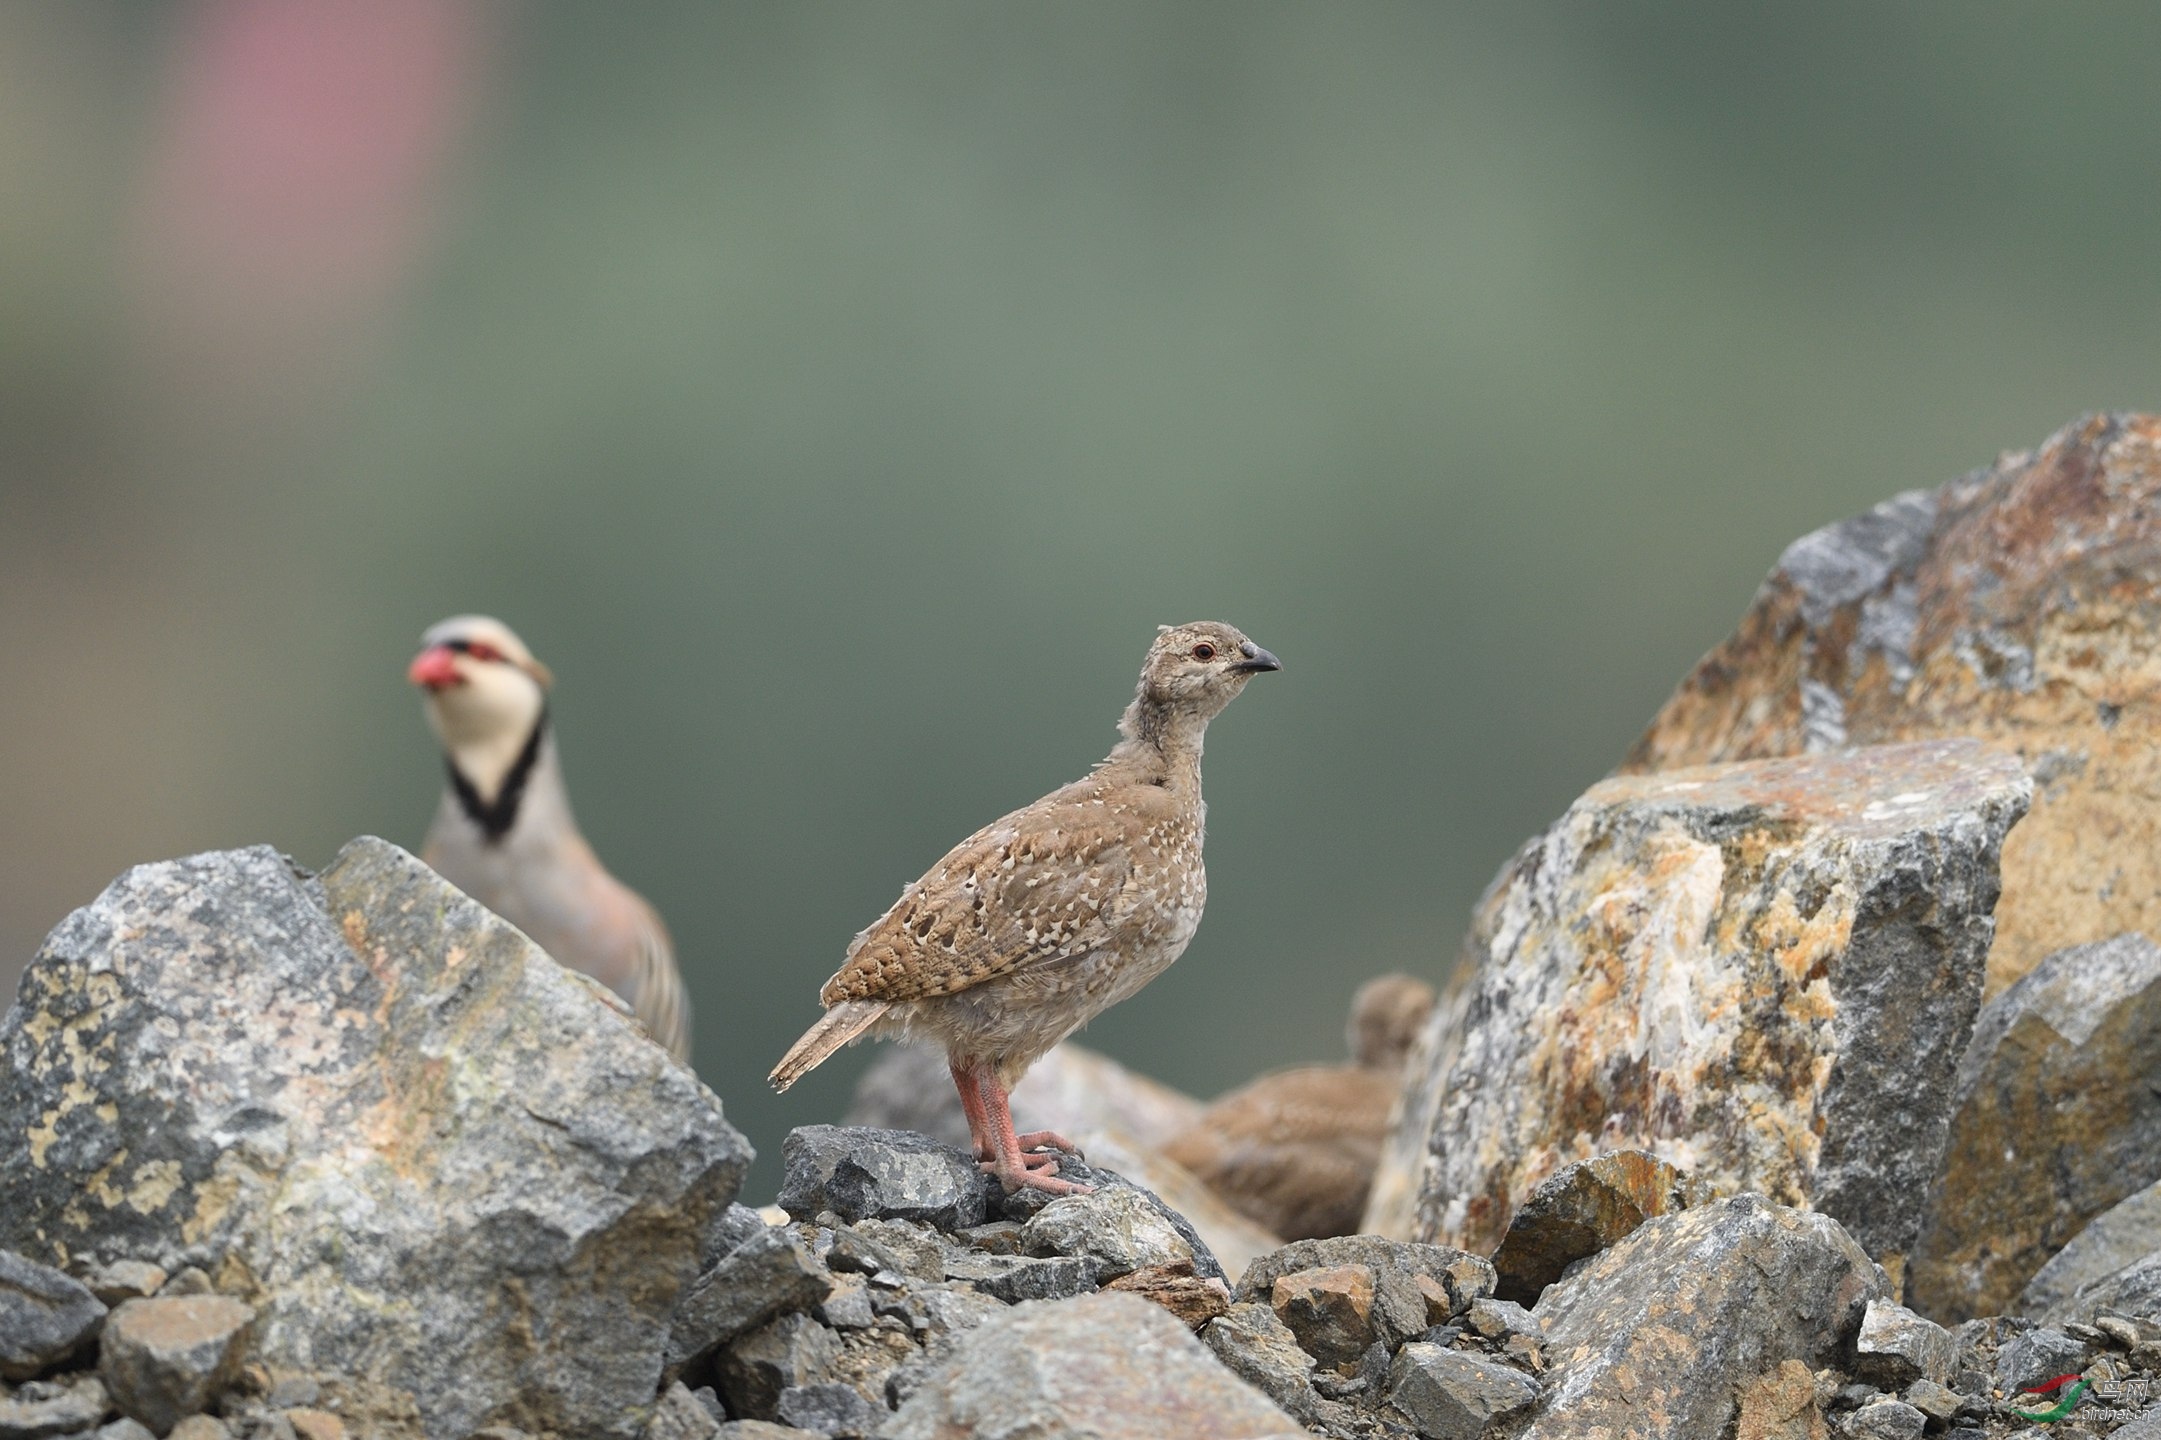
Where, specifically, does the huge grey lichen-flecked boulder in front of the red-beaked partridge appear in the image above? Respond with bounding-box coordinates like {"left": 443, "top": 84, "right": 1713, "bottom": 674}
{"left": 0, "top": 839, "right": 750, "bottom": 1440}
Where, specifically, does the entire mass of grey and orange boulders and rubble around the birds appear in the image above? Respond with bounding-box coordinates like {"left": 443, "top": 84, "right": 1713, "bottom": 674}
{"left": 21, "top": 408, "right": 2161, "bottom": 1440}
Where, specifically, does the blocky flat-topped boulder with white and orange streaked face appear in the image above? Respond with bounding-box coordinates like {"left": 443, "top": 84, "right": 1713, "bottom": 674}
{"left": 1368, "top": 739, "right": 2031, "bottom": 1256}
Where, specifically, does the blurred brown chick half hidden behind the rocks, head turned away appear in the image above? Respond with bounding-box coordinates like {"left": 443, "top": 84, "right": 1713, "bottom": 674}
{"left": 1163, "top": 975, "right": 1433, "bottom": 1241}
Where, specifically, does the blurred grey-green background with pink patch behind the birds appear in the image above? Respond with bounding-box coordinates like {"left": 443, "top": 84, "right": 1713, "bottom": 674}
{"left": 0, "top": 0, "right": 2161, "bottom": 1196}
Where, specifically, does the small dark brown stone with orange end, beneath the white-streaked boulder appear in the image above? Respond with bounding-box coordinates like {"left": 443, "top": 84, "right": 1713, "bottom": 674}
{"left": 1493, "top": 1150, "right": 1709, "bottom": 1306}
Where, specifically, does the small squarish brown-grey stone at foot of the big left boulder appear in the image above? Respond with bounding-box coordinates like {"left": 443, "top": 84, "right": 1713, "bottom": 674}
{"left": 97, "top": 1295, "right": 255, "bottom": 1436}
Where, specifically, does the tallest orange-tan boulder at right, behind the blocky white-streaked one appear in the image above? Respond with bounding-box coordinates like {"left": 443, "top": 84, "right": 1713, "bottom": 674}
{"left": 1627, "top": 415, "right": 2161, "bottom": 995}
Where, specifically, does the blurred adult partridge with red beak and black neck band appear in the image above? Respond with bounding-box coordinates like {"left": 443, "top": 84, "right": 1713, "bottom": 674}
{"left": 406, "top": 614, "right": 689, "bottom": 1059}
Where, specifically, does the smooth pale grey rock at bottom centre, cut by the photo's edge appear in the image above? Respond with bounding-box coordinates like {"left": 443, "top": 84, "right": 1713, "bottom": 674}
{"left": 882, "top": 1293, "right": 1303, "bottom": 1440}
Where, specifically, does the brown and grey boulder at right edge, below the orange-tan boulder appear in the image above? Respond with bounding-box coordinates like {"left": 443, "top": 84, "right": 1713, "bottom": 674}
{"left": 1910, "top": 934, "right": 2161, "bottom": 1321}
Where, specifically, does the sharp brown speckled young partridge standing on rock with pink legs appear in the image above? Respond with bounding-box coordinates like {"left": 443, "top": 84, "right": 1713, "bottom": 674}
{"left": 771, "top": 621, "right": 1281, "bottom": 1194}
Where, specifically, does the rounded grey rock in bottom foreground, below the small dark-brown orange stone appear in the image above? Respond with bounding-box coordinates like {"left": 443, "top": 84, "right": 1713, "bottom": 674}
{"left": 1521, "top": 1196, "right": 1878, "bottom": 1440}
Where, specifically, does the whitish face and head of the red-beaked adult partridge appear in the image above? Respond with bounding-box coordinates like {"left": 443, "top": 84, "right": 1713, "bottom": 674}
{"left": 406, "top": 614, "right": 549, "bottom": 800}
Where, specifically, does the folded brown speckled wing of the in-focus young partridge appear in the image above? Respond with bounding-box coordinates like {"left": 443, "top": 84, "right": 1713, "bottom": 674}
{"left": 819, "top": 796, "right": 1135, "bottom": 1005}
